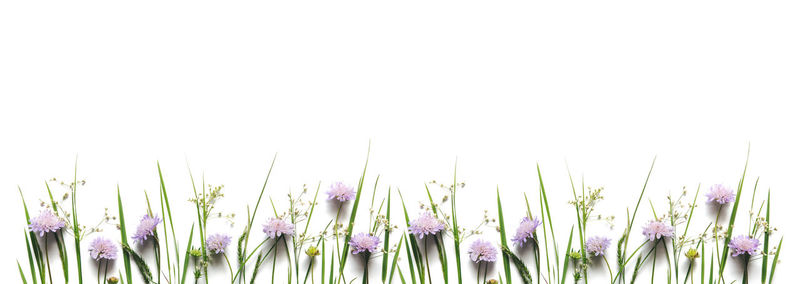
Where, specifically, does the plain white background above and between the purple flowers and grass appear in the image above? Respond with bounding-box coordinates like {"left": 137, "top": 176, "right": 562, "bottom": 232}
{"left": 0, "top": 1, "right": 800, "bottom": 283}
